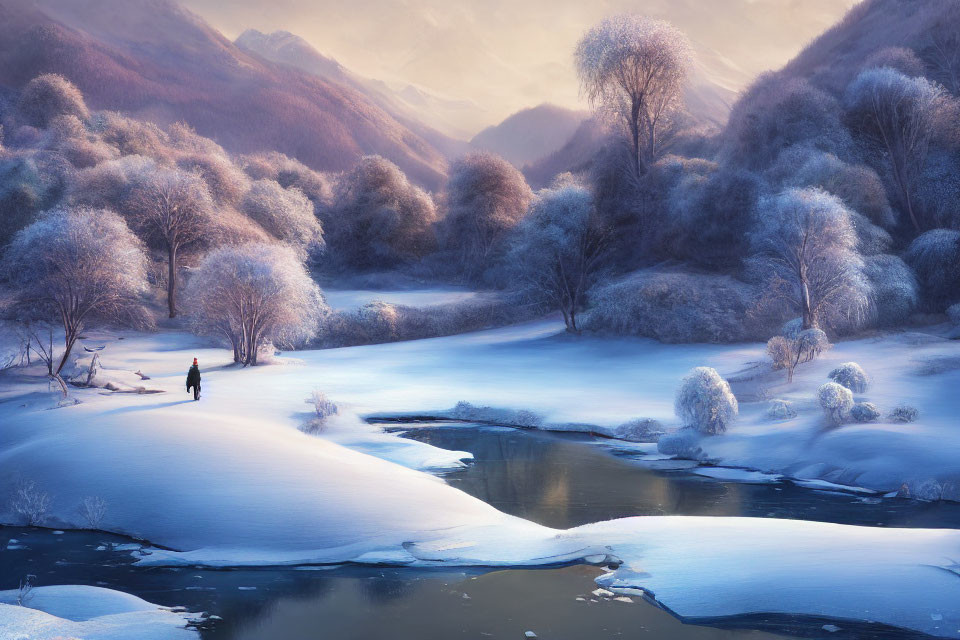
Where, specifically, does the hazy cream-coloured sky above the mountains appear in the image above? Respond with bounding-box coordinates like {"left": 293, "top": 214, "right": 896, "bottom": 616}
{"left": 181, "top": 0, "right": 856, "bottom": 126}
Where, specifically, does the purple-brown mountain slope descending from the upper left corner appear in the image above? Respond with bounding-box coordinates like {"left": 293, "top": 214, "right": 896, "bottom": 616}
{"left": 0, "top": 0, "right": 446, "bottom": 188}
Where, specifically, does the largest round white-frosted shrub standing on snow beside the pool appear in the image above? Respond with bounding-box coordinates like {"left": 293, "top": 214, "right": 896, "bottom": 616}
{"left": 673, "top": 367, "right": 738, "bottom": 435}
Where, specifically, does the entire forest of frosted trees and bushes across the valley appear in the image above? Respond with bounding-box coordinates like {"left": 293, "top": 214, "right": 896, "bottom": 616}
{"left": 0, "top": 3, "right": 960, "bottom": 376}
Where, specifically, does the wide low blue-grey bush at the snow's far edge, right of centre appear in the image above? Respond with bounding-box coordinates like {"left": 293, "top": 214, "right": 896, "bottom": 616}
{"left": 583, "top": 270, "right": 761, "bottom": 342}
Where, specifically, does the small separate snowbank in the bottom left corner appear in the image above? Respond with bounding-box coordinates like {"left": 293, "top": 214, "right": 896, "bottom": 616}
{"left": 0, "top": 585, "right": 200, "bottom": 640}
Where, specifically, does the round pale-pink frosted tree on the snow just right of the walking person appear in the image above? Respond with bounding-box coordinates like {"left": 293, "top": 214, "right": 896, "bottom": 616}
{"left": 187, "top": 243, "right": 329, "bottom": 365}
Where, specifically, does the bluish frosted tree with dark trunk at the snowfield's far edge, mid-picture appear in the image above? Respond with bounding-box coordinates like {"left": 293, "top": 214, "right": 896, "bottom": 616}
{"left": 508, "top": 186, "right": 609, "bottom": 332}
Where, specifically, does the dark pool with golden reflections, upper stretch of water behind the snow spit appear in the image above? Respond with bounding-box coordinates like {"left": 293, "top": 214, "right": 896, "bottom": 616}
{"left": 406, "top": 426, "right": 960, "bottom": 528}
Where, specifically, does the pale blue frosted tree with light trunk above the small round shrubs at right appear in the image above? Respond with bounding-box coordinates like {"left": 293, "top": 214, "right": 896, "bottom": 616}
{"left": 752, "top": 189, "right": 869, "bottom": 329}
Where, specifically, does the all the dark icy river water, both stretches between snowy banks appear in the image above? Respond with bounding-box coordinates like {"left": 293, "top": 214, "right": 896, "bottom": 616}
{"left": 0, "top": 424, "right": 960, "bottom": 640}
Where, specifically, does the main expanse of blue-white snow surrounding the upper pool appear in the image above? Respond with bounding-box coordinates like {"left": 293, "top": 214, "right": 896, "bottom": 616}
{"left": 0, "top": 320, "right": 960, "bottom": 637}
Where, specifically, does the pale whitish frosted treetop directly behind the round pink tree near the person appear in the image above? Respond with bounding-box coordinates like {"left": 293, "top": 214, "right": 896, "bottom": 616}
{"left": 240, "top": 180, "right": 323, "bottom": 258}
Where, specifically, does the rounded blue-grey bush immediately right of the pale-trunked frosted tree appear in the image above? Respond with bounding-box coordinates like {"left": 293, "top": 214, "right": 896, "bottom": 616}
{"left": 863, "top": 254, "right": 920, "bottom": 327}
